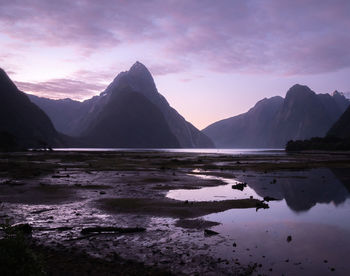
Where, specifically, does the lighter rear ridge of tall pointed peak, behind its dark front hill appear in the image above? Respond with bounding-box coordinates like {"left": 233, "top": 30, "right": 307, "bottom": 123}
{"left": 32, "top": 62, "right": 214, "bottom": 148}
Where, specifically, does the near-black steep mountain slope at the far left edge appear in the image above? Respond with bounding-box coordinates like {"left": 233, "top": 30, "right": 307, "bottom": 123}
{"left": 0, "top": 69, "right": 60, "bottom": 150}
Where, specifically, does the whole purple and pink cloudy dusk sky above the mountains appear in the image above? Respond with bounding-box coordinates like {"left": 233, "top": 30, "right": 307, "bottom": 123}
{"left": 0, "top": 0, "right": 350, "bottom": 129}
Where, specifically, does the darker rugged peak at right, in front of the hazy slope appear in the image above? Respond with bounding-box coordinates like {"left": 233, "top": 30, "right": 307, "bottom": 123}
{"left": 273, "top": 84, "right": 349, "bottom": 146}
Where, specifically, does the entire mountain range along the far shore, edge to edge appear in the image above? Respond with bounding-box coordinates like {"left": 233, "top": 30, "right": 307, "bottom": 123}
{"left": 0, "top": 62, "right": 350, "bottom": 149}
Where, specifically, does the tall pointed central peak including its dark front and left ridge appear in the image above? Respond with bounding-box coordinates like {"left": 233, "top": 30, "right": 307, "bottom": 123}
{"left": 31, "top": 62, "right": 213, "bottom": 148}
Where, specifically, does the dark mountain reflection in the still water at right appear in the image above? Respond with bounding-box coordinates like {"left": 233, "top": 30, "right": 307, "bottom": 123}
{"left": 240, "top": 168, "right": 350, "bottom": 212}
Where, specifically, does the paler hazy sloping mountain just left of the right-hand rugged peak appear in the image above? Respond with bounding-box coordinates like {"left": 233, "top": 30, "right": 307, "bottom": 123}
{"left": 203, "top": 96, "right": 283, "bottom": 148}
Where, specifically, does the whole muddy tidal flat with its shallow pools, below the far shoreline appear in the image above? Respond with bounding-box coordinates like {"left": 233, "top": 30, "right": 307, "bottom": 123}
{"left": 0, "top": 151, "right": 350, "bottom": 275}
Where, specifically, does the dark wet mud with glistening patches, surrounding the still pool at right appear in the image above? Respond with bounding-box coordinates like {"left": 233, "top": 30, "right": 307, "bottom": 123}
{"left": 0, "top": 152, "right": 350, "bottom": 275}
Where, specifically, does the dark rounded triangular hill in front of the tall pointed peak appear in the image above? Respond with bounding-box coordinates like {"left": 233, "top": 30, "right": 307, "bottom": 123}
{"left": 82, "top": 87, "right": 179, "bottom": 148}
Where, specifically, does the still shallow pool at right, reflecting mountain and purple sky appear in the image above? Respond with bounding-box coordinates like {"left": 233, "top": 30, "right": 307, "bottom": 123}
{"left": 167, "top": 168, "right": 350, "bottom": 275}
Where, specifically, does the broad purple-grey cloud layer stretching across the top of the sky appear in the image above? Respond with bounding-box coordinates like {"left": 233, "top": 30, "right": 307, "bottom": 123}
{"left": 0, "top": 0, "right": 350, "bottom": 75}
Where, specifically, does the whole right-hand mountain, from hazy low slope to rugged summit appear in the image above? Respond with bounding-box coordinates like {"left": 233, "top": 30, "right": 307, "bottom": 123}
{"left": 203, "top": 84, "right": 349, "bottom": 148}
